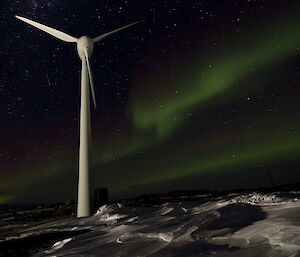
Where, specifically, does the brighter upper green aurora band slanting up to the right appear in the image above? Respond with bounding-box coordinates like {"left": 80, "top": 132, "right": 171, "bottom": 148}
{"left": 99, "top": 11, "right": 300, "bottom": 161}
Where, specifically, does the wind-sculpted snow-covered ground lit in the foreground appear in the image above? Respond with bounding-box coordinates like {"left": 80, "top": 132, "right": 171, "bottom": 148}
{"left": 7, "top": 192, "right": 300, "bottom": 257}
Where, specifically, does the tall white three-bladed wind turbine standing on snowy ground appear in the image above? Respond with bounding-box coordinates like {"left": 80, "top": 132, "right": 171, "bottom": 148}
{"left": 15, "top": 15, "right": 137, "bottom": 217}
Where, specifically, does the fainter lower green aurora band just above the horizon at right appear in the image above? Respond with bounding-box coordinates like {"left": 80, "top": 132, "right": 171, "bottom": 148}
{"left": 101, "top": 108, "right": 300, "bottom": 192}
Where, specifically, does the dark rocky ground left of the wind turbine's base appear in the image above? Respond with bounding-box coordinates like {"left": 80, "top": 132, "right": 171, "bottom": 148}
{"left": 0, "top": 201, "right": 78, "bottom": 257}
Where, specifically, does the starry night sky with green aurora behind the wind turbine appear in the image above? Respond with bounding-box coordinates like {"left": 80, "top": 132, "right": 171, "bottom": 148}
{"left": 0, "top": 0, "right": 300, "bottom": 204}
